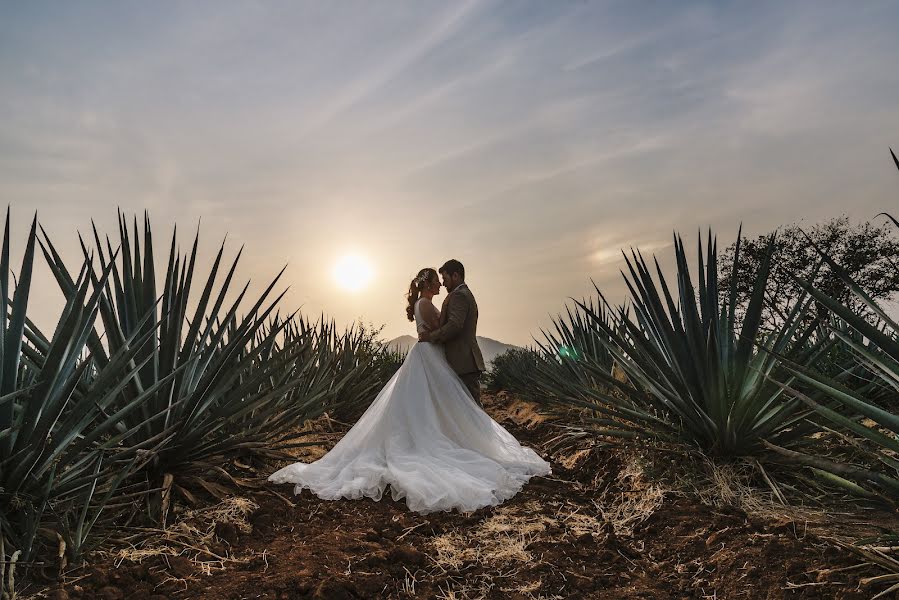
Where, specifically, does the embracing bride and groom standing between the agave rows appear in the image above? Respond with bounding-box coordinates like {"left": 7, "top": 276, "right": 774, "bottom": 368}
{"left": 269, "top": 260, "right": 550, "bottom": 513}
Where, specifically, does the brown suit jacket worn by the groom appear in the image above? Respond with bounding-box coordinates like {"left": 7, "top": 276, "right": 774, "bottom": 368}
{"left": 431, "top": 284, "right": 485, "bottom": 375}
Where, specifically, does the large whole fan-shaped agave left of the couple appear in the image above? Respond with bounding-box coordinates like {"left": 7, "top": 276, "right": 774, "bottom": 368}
{"left": 41, "top": 213, "right": 342, "bottom": 517}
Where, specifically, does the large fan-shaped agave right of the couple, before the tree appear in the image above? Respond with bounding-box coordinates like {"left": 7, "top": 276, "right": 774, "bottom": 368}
{"left": 536, "top": 232, "right": 823, "bottom": 456}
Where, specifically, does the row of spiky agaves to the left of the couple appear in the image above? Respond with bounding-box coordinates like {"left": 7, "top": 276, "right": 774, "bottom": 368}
{"left": 0, "top": 211, "right": 398, "bottom": 595}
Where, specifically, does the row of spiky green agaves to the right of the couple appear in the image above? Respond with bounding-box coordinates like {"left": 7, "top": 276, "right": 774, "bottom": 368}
{"left": 491, "top": 151, "right": 899, "bottom": 596}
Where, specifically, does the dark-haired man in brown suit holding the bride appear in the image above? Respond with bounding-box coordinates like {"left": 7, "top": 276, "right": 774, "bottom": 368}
{"left": 418, "top": 259, "right": 484, "bottom": 404}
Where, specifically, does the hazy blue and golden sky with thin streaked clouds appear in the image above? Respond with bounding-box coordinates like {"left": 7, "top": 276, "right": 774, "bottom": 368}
{"left": 0, "top": 0, "right": 899, "bottom": 345}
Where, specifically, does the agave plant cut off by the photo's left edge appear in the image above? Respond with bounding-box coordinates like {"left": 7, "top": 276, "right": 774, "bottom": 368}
{"left": 0, "top": 211, "right": 169, "bottom": 591}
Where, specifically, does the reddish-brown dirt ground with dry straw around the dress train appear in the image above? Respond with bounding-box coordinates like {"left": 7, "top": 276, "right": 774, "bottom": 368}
{"left": 49, "top": 397, "right": 875, "bottom": 600}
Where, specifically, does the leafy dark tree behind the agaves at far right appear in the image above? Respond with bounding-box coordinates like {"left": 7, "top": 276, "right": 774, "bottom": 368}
{"left": 718, "top": 215, "right": 899, "bottom": 329}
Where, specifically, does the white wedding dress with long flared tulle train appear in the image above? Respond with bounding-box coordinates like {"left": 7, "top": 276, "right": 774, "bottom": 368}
{"left": 269, "top": 300, "right": 550, "bottom": 513}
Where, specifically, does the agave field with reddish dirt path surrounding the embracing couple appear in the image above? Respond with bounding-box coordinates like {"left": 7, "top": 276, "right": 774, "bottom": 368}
{"left": 0, "top": 155, "right": 899, "bottom": 600}
